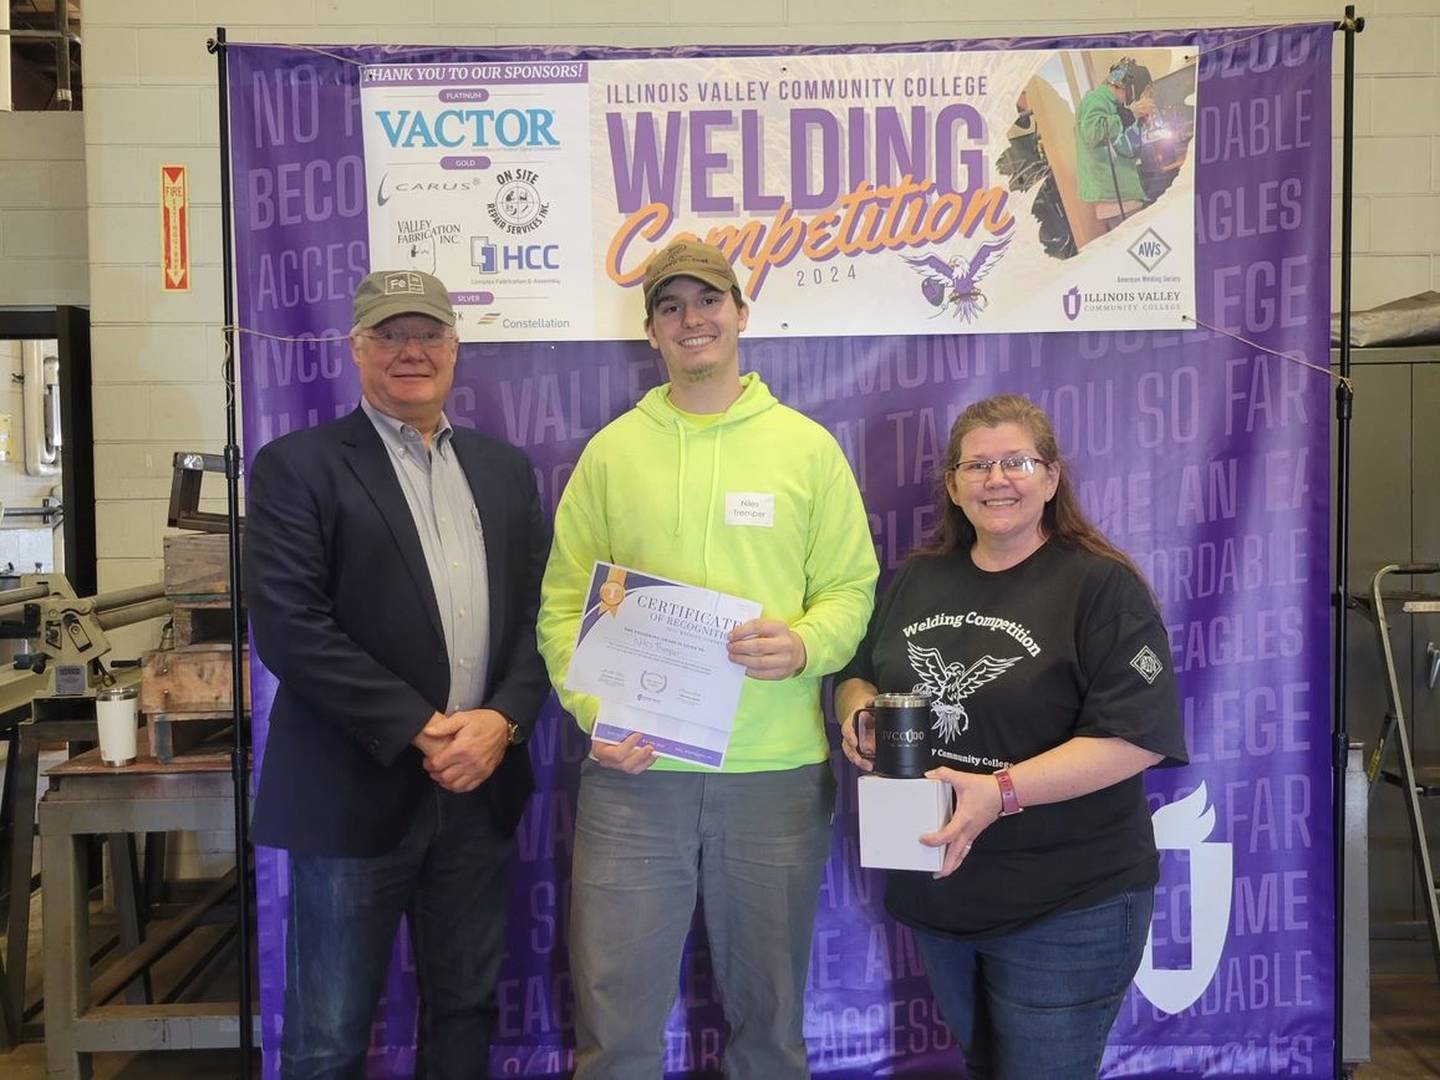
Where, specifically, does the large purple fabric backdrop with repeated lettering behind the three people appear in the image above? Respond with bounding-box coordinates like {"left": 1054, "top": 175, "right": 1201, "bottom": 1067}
{"left": 229, "top": 24, "right": 1336, "bottom": 1077}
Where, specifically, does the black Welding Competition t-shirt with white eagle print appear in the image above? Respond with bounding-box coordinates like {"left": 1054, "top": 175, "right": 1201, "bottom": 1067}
{"left": 837, "top": 543, "right": 1187, "bottom": 936}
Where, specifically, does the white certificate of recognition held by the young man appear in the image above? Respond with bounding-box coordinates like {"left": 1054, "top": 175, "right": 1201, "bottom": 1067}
{"left": 564, "top": 562, "right": 760, "bottom": 768}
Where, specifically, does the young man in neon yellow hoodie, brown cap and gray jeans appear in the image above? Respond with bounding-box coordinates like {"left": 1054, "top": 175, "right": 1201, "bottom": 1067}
{"left": 539, "top": 240, "right": 877, "bottom": 1080}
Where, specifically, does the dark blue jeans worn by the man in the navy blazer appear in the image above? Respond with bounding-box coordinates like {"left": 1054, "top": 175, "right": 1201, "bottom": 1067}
{"left": 281, "top": 788, "right": 513, "bottom": 1080}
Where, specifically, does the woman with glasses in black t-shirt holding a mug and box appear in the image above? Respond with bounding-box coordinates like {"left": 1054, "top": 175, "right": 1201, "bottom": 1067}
{"left": 835, "top": 395, "right": 1187, "bottom": 1080}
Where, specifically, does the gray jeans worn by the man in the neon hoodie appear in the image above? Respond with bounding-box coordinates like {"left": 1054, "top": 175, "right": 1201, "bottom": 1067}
{"left": 570, "top": 762, "right": 835, "bottom": 1080}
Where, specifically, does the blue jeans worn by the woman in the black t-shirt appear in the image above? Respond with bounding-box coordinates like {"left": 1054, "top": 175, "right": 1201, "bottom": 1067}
{"left": 914, "top": 888, "right": 1155, "bottom": 1080}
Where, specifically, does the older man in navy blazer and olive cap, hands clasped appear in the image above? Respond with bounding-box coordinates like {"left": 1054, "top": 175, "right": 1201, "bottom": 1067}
{"left": 245, "top": 271, "right": 549, "bottom": 1080}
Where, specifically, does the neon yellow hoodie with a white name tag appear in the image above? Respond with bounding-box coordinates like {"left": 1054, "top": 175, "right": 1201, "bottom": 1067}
{"left": 537, "top": 372, "right": 878, "bottom": 772}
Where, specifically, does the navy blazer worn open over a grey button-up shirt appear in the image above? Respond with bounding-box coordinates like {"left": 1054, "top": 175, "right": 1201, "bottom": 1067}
{"left": 245, "top": 409, "right": 550, "bottom": 855}
